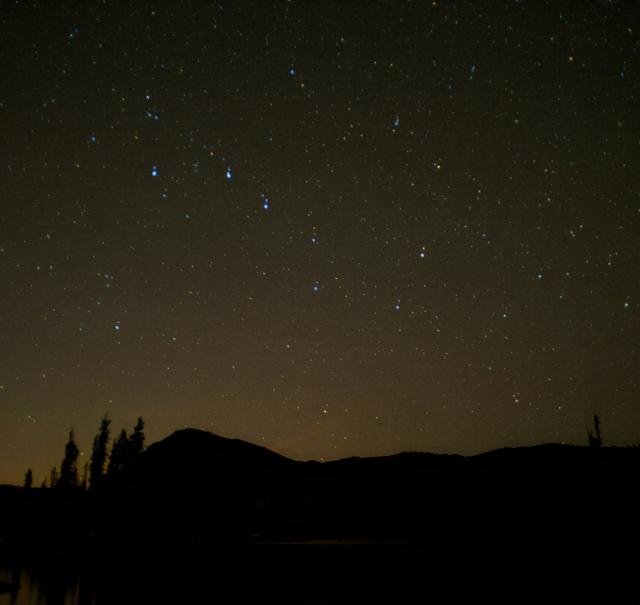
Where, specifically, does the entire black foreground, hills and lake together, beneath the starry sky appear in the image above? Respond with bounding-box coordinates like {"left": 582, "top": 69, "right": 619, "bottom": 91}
{"left": 0, "top": 431, "right": 640, "bottom": 605}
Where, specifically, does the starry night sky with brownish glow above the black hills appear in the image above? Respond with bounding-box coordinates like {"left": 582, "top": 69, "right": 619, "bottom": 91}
{"left": 0, "top": 0, "right": 640, "bottom": 485}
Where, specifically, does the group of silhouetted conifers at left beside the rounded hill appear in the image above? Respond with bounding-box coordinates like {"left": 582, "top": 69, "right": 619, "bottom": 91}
{"left": 24, "top": 414, "right": 145, "bottom": 490}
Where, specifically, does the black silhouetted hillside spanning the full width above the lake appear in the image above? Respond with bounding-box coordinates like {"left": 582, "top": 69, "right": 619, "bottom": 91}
{"left": 0, "top": 429, "right": 640, "bottom": 557}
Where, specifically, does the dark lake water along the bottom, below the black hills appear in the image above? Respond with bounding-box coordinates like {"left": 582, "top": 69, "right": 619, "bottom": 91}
{"left": 0, "top": 543, "right": 638, "bottom": 605}
